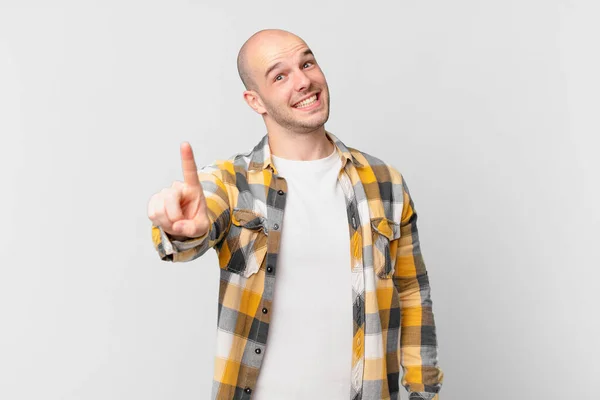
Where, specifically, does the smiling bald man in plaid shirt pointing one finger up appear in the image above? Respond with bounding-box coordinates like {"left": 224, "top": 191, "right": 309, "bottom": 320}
{"left": 148, "top": 30, "right": 443, "bottom": 400}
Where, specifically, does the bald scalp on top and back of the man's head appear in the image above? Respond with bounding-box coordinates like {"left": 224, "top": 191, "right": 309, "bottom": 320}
{"left": 237, "top": 29, "right": 306, "bottom": 91}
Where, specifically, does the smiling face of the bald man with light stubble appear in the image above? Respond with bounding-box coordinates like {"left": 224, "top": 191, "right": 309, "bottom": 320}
{"left": 248, "top": 37, "right": 329, "bottom": 133}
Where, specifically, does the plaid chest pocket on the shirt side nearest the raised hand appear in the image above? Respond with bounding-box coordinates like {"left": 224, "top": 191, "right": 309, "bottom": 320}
{"left": 218, "top": 208, "right": 267, "bottom": 278}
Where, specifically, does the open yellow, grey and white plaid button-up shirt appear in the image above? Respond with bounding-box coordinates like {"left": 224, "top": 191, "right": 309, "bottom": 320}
{"left": 152, "top": 132, "right": 443, "bottom": 400}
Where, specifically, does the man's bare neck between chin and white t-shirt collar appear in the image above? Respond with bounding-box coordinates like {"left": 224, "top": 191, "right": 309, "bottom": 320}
{"left": 267, "top": 126, "right": 334, "bottom": 161}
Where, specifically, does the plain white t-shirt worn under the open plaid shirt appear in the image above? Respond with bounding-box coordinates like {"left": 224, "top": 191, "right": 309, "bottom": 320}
{"left": 252, "top": 148, "right": 353, "bottom": 400}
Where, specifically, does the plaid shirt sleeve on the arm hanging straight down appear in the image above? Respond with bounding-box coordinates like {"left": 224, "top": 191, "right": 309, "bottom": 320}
{"left": 393, "top": 176, "right": 444, "bottom": 400}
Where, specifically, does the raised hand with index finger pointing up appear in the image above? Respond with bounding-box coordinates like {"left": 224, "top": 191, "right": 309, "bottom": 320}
{"left": 148, "top": 142, "right": 210, "bottom": 240}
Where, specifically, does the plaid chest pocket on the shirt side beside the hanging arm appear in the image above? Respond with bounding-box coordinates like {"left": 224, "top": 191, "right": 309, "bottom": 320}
{"left": 371, "top": 218, "right": 400, "bottom": 279}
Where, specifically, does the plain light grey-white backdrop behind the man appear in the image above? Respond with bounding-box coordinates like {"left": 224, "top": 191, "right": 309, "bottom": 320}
{"left": 0, "top": 0, "right": 600, "bottom": 400}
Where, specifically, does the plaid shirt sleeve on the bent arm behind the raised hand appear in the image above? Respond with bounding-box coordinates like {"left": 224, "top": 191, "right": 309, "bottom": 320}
{"left": 152, "top": 164, "right": 231, "bottom": 262}
